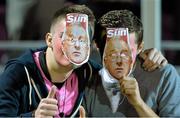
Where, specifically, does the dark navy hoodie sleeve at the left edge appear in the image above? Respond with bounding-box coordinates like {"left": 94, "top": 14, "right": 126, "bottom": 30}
{"left": 0, "top": 64, "right": 28, "bottom": 117}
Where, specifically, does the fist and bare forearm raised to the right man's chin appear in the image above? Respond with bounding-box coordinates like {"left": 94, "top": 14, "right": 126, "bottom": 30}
{"left": 119, "top": 77, "right": 158, "bottom": 118}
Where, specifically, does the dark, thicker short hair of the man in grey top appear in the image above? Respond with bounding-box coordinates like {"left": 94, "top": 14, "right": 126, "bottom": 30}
{"left": 95, "top": 10, "right": 143, "bottom": 56}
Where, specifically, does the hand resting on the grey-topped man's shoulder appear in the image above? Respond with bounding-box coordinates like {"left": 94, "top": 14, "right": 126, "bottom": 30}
{"left": 140, "top": 48, "right": 168, "bottom": 71}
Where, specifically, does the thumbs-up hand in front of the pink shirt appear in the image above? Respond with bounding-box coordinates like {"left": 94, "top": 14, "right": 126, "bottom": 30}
{"left": 35, "top": 86, "right": 58, "bottom": 118}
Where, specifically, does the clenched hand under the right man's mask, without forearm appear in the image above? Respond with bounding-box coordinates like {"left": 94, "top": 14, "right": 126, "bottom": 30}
{"left": 119, "top": 77, "right": 142, "bottom": 107}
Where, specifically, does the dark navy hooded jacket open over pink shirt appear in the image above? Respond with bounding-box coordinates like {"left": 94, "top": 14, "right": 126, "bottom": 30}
{"left": 0, "top": 48, "right": 99, "bottom": 117}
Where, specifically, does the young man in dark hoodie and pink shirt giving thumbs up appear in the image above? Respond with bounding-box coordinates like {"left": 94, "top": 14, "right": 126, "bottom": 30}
{"left": 0, "top": 5, "right": 96, "bottom": 117}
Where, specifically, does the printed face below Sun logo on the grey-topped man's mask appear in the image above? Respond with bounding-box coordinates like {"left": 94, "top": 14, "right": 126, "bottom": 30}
{"left": 104, "top": 40, "right": 132, "bottom": 79}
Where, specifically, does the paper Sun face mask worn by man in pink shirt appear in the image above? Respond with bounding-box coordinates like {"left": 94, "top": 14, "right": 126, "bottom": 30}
{"left": 62, "top": 13, "right": 90, "bottom": 66}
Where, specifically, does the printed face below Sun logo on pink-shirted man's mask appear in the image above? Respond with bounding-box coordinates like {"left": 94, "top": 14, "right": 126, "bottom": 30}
{"left": 63, "top": 25, "right": 89, "bottom": 64}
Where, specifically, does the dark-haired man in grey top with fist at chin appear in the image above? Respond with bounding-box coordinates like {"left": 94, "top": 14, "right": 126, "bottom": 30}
{"left": 83, "top": 10, "right": 180, "bottom": 117}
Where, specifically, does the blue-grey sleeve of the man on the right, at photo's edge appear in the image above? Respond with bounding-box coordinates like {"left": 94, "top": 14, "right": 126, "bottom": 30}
{"left": 158, "top": 65, "right": 180, "bottom": 117}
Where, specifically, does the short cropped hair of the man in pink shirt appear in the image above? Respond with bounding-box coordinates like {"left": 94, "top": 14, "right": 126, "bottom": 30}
{"left": 51, "top": 5, "right": 96, "bottom": 39}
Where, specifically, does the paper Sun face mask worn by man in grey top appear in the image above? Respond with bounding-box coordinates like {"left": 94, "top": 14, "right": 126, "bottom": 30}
{"left": 103, "top": 28, "right": 134, "bottom": 79}
